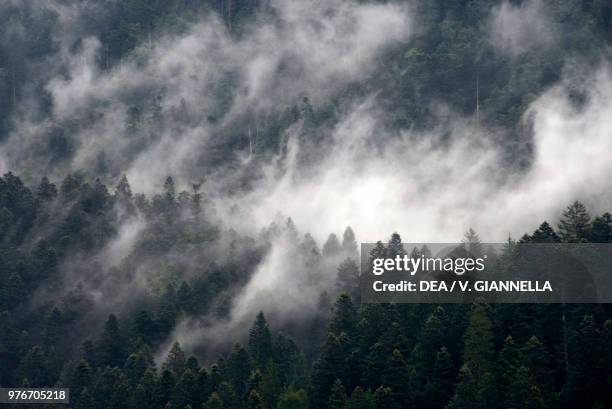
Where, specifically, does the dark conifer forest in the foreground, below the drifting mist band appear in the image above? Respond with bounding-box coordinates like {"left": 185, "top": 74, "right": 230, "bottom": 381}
{"left": 0, "top": 174, "right": 612, "bottom": 409}
